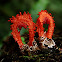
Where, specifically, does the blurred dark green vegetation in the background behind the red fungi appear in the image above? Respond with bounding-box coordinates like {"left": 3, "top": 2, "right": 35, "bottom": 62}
{"left": 0, "top": 0, "right": 62, "bottom": 48}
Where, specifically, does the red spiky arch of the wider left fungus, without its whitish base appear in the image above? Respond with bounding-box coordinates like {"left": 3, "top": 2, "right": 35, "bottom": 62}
{"left": 8, "top": 12, "right": 35, "bottom": 48}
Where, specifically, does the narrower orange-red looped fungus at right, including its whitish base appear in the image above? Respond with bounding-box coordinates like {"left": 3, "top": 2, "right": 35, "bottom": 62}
{"left": 36, "top": 10, "right": 55, "bottom": 48}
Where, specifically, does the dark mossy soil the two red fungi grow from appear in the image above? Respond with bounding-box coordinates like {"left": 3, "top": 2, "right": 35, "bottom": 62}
{"left": 0, "top": 30, "right": 62, "bottom": 62}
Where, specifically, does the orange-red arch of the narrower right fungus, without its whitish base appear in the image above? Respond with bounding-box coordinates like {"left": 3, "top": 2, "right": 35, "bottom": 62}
{"left": 37, "top": 10, "right": 55, "bottom": 39}
